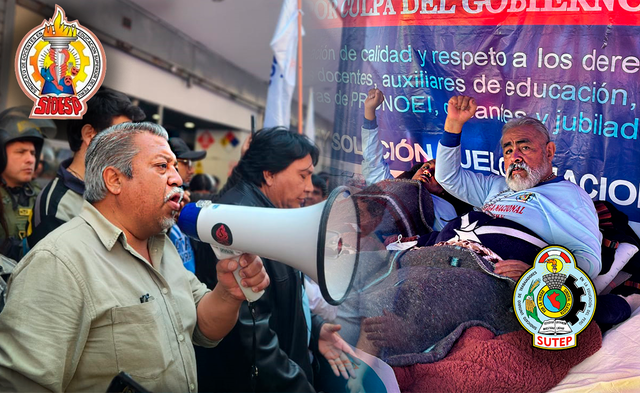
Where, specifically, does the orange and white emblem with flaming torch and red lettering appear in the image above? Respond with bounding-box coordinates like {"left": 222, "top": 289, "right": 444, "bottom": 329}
{"left": 16, "top": 5, "right": 107, "bottom": 119}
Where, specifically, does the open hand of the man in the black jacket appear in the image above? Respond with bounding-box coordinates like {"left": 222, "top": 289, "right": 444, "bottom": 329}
{"left": 318, "top": 323, "right": 360, "bottom": 379}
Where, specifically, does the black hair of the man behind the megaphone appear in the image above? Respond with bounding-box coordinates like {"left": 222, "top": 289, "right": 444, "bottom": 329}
{"left": 234, "top": 127, "right": 320, "bottom": 187}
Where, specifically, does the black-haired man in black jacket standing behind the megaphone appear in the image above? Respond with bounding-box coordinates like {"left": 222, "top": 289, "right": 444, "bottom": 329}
{"left": 196, "top": 128, "right": 354, "bottom": 392}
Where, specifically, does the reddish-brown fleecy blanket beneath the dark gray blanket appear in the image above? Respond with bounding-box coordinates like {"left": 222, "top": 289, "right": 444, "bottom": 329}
{"left": 393, "top": 322, "right": 602, "bottom": 393}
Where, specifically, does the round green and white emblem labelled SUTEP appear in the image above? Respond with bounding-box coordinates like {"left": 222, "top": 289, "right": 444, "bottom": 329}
{"left": 513, "top": 246, "right": 596, "bottom": 349}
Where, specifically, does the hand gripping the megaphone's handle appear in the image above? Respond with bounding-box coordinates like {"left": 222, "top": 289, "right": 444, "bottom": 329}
{"left": 216, "top": 254, "right": 270, "bottom": 301}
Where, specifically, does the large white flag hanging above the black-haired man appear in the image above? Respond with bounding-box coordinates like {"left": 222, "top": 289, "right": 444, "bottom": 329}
{"left": 264, "top": 0, "right": 300, "bottom": 127}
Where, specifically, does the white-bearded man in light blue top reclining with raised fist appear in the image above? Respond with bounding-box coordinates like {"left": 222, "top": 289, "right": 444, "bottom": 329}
{"left": 436, "top": 96, "right": 602, "bottom": 280}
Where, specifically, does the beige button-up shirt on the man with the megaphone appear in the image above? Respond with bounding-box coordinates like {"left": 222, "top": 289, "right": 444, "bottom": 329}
{"left": 0, "top": 202, "right": 217, "bottom": 392}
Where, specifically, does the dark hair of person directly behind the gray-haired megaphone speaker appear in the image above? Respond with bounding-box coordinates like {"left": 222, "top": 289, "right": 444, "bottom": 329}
{"left": 67, "top": 88, "right": 146, "bottom": 153}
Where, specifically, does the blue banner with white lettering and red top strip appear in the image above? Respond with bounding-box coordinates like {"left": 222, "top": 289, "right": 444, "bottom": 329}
{"left": 315, "top": 0, "right": 640, "bottom": 221}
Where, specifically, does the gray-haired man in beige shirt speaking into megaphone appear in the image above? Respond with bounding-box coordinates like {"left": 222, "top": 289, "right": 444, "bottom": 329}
{"left": 0, "top": 123, "right": 269, "bottom": 392}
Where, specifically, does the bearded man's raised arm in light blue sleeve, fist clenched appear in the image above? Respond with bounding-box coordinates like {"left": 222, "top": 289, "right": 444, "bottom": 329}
{"left": 435, "top": 96, "right": 507, "bottom": 207}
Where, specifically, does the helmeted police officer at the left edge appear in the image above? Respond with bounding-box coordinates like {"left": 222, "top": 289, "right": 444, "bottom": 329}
{"left": 0, "top": 108, "right": 47, "bottom": 260}
